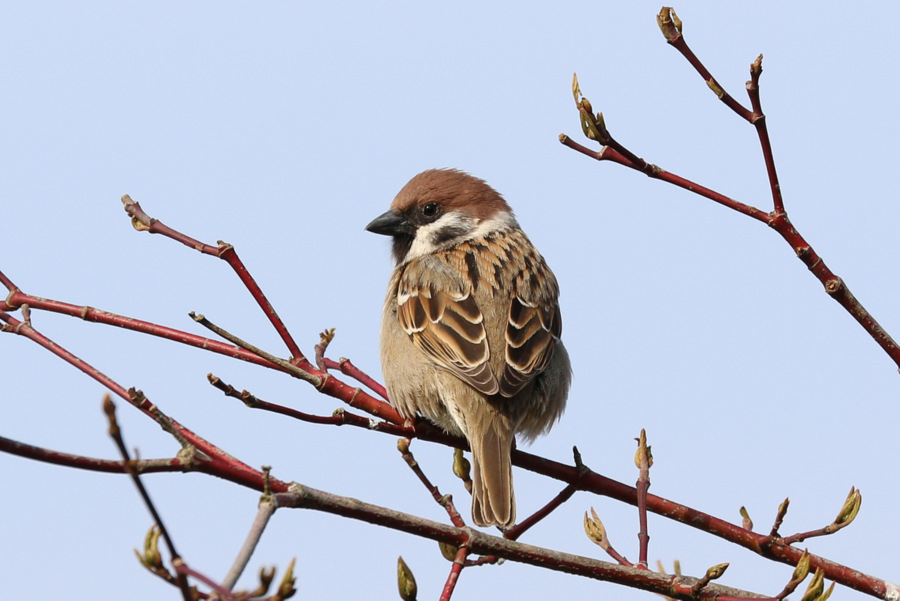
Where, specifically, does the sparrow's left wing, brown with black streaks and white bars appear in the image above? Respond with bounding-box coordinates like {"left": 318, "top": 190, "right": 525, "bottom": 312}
{"left": 397, "top": 266, "right": 500, "bottom": 395}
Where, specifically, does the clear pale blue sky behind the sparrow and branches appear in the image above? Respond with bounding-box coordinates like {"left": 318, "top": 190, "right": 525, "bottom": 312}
{"left": 0, "top": 0, "right": 900, "bottom": 600}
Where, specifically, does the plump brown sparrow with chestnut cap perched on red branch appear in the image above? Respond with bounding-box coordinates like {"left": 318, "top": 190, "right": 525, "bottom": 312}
{"left": 366, "top": 169, "right": 572, "bottom": 527}
